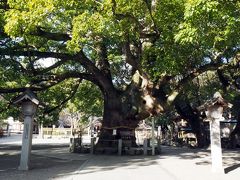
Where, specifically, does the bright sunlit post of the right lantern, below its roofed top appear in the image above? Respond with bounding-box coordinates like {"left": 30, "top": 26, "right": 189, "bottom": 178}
{"left": 210, "top": 118, "right": 224, "bottom": 173}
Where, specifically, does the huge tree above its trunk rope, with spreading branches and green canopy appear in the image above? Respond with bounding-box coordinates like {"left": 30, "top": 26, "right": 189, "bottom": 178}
{"left": 0, "top": 0, "right": 240, "bottom": 146}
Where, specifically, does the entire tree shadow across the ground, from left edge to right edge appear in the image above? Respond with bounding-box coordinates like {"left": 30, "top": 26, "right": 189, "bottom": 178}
{"left": 0, "top": 144, "right": 240, "bottom": 180}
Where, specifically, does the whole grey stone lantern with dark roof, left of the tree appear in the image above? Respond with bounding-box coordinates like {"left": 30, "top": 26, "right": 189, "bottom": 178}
{"left": 13, "top": 89, "right": 39, "bottom": 170}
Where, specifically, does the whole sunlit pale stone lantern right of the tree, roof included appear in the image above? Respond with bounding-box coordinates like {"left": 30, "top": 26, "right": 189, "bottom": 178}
{"left": 201, "top": 92, "right": 232, "bottom": 173}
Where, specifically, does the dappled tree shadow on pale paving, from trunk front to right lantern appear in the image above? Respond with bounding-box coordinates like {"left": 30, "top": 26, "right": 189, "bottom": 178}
{"left": 57, "top": 146, "right": 240, "bottom": 179}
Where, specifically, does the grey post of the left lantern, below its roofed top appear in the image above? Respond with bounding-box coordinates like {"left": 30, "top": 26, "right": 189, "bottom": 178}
{"left": 18, "top": 116, "right": 33, "bottom": 170}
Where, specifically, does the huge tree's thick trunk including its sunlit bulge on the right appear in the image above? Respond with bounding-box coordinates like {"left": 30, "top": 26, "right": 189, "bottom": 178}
{"left": 97, "top": 76, "right": 163, "bottom": 148}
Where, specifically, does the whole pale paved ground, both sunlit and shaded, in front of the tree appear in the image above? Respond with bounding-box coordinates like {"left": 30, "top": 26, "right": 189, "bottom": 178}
{"left": 0, "top": 134, "right": 240, "bottom": 180}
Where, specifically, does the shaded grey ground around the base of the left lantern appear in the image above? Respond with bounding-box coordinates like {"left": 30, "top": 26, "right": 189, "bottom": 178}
{"left": 0, "top": 144, "right": 86, "bottom": 180}
